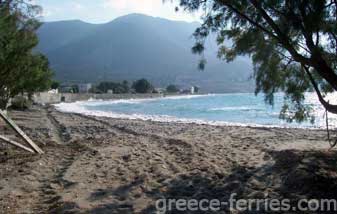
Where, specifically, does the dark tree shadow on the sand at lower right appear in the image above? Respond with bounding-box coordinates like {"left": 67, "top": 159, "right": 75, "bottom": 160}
{"left": 57, "top": 150, "right": 337, "bottom": 214}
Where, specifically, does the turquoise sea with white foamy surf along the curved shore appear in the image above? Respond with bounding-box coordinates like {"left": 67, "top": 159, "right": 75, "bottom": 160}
{"left": 56, "top": 93, "right": 337, "bottom": 128}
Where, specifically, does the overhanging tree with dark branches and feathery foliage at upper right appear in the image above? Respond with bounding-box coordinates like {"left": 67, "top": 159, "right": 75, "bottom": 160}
{"left": 180, "top": 0, "right": 337, "bottom": 122}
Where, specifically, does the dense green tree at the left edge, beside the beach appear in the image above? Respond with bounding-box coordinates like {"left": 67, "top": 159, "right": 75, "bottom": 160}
{"left": 0, "top": 0, "right": 52, "bottom": 109}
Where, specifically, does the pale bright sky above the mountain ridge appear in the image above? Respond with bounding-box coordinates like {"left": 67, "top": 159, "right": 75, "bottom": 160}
{"left": 32, "top": 0, "right": 199, "bottom": 23}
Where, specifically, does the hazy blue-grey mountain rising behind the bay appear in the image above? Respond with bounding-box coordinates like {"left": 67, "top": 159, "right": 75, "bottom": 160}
{"left": 38, "top": 14, "right": 254, "bottom": 92}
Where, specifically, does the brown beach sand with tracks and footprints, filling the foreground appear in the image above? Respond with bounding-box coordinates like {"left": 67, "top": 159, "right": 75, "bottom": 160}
{"left": 0, "top": 107, "right": 337, "bottom": 213}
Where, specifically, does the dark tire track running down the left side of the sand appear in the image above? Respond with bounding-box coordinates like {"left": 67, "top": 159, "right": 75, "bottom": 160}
{"left": 34, "top": 109, "right": 95, "bottom": 213}
